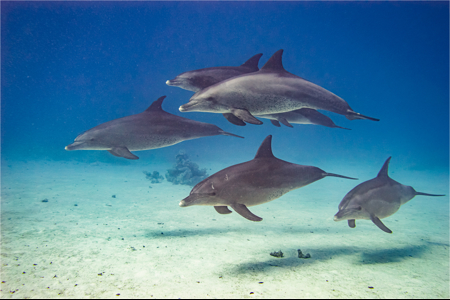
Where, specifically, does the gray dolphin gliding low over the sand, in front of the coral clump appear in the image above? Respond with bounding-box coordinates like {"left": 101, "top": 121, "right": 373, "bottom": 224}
{"left": 180, "top": 135, "right": 355, "bottom": 221}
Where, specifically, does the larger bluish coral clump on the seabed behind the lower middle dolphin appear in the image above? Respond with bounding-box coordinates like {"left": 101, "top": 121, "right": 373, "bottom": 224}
{"left": 166, "top": 151, "right": 208, "bottom": 186}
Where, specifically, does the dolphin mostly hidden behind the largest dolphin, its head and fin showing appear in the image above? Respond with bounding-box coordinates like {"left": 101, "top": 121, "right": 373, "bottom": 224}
{"left": 166, "top": 53, "right": 262, "bottom": 92}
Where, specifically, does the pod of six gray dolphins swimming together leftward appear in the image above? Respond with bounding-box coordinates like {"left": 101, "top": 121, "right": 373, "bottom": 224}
{"left": 65, "top": 50, "right": 445, "bottom": 233}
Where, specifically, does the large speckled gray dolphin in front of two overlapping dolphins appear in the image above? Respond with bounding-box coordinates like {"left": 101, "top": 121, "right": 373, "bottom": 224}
{"left": 179, "top": 49, "right": 379, "bottom": 125}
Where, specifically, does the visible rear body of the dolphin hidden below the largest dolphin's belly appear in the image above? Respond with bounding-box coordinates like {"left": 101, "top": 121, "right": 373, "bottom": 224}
{"left": 255, "top": 108, "right": 350, "bottom": 130}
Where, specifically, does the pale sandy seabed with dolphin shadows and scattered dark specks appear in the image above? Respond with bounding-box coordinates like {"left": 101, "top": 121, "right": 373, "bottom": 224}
{"left": 1, "top": 161, "right": 450, "bottom": 298}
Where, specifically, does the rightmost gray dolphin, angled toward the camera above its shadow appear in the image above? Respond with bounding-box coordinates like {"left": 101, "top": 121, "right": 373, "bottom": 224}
{"left": 334, "top": 157, "right": 445, "bottom": 233}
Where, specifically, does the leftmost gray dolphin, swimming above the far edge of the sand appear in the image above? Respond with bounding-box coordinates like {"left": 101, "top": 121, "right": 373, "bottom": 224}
{"left": 65, "top": 96, "right": 242, "bottom": 159}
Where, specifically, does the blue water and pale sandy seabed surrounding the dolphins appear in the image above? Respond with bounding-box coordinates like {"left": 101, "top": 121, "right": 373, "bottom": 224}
{"left": 1, "top": 1, "right": 450, "bottom": 298}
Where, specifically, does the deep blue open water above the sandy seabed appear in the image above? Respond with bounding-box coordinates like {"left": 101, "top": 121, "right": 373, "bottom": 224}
{"left": 1, "top": 2, "right": 449, "bottom": 296}
